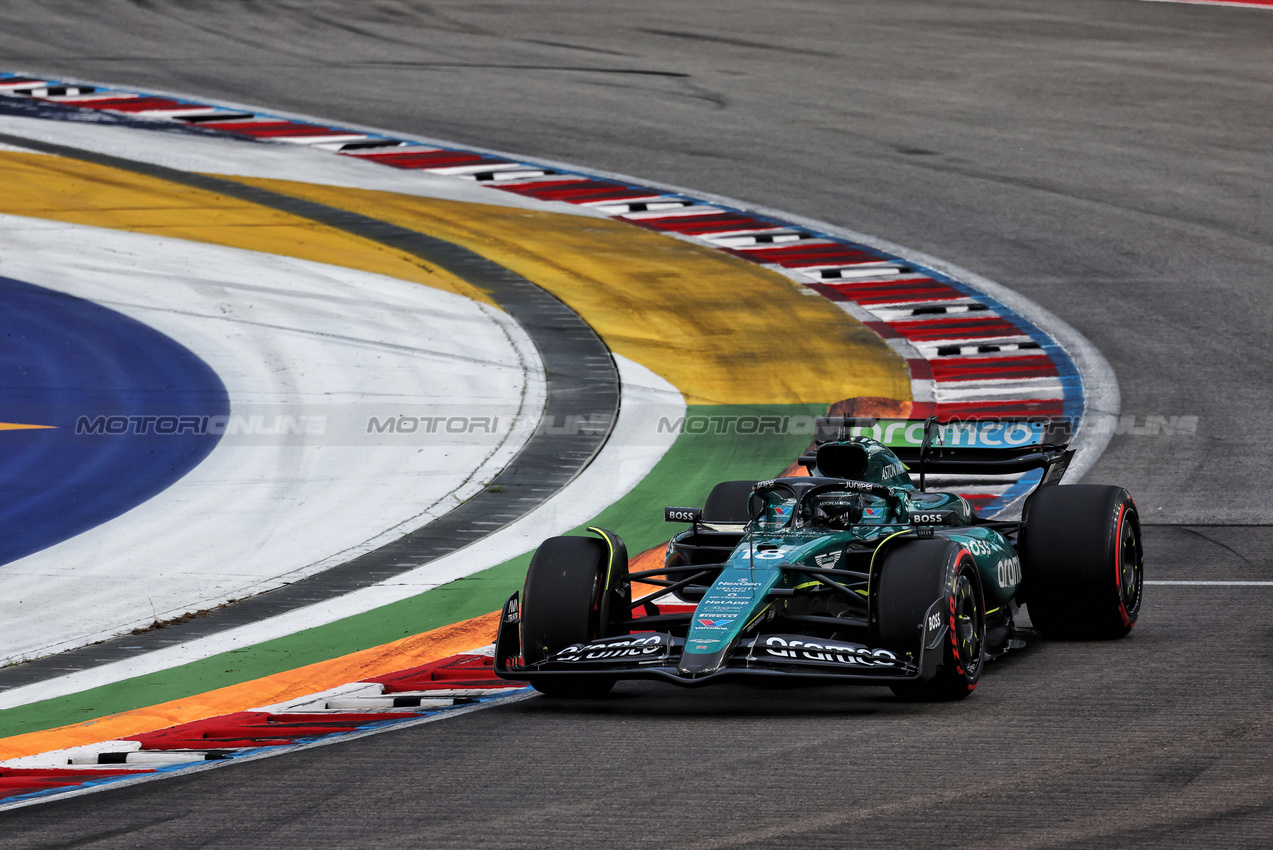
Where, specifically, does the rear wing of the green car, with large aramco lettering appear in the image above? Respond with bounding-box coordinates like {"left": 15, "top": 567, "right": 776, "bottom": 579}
{"left": 799, "top": 416, "right": 1074, "bottom": 489}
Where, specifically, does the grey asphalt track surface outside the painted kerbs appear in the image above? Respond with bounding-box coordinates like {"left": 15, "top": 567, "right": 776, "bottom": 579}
{"left": 0, "top": 0, "right": 1273, "bottom": 847}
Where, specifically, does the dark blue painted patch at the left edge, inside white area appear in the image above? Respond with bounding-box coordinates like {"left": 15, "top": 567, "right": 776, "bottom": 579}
{"left": 0, "top": 277, "right": 229, "bottom": 564}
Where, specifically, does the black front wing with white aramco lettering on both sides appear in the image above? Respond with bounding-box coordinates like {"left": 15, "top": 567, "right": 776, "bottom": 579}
{"left": 495, "top": 593, "right": 941, "bottom": 687}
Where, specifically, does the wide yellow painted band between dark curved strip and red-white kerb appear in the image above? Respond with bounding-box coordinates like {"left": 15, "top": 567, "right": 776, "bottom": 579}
{"left": 229, "top": 177, "right": 910, "bottom": 405}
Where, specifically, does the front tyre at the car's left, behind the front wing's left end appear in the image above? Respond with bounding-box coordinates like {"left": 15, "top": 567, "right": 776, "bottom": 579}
{"left": 521, "top": 537, "right": 615, "bottom": 697}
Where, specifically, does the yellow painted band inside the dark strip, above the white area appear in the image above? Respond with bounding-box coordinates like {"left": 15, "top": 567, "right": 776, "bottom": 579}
{"left": 0, "top": 151, "right": 493, "bottom": 304}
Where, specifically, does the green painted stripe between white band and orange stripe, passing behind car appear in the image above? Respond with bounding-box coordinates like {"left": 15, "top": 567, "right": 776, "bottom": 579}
{"left": 0, "top": 405, "right": 826, "bottom": 737}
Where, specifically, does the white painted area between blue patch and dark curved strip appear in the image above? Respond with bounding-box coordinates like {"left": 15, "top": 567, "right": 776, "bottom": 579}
{"left": 0, "top": 216, "right": 545, "bottom": 662}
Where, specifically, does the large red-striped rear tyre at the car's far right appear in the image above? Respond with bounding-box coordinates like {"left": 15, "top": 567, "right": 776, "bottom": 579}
{"left": 1020, "top": 485, "right": 1144, "bottom": 640}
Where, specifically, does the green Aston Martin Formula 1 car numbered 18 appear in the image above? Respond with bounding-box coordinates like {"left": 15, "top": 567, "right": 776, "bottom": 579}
{"left": 495, "top": 419, "right": 1143, "bottom": 700}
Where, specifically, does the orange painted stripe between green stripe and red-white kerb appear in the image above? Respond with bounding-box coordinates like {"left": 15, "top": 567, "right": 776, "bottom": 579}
{"left": 0, "top": 611, "right": 500, "bottom": 761}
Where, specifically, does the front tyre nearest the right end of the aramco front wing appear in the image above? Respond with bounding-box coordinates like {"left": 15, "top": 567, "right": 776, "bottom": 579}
{"left": 878, "top": 538, "right": 985, "bottom": 702}
